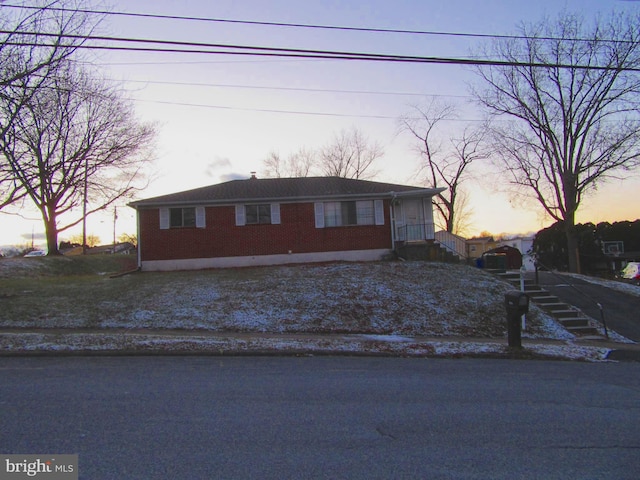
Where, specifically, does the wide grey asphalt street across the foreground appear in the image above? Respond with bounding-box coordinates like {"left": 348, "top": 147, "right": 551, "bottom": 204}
{"left": 0, "top": 357, "right": 640, "bottom": 480}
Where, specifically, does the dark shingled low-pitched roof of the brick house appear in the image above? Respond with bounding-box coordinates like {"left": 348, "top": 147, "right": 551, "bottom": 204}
{"left": 129, "top": 177, "right": 443, "bottom": 208}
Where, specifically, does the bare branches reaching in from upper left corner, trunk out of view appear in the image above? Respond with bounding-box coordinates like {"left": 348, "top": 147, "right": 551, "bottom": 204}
{"left": 0, "top": 0, "right": 100, "bottom": 209}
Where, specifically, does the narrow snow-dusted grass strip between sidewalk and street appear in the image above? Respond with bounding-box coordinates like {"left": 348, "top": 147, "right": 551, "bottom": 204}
{"left": 0, "top": 333, "right": 610, "bottom": 362}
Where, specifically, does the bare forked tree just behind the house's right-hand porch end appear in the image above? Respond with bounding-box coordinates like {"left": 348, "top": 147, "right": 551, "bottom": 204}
{"left": 401, "top": 100, "right": 489, "bottom": 233}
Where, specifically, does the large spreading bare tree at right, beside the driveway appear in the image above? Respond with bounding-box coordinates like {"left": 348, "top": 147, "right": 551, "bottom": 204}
{"left": 474, "top": 14, "right": 640, "bottom": 272}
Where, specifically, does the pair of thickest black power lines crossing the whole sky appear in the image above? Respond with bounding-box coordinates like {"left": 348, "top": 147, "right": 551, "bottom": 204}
{"left": 0, "top": 30, "right": 640, "bottom": 72}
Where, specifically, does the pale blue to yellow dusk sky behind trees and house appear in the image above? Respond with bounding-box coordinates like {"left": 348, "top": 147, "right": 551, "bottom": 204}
{"left": 0, "top": 0, "right": 640, "bottom": 248}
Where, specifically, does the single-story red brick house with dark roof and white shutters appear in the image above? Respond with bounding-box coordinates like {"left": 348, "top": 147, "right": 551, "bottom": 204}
{"left": 130, "top": 175, "right": 442, "bottom": 270}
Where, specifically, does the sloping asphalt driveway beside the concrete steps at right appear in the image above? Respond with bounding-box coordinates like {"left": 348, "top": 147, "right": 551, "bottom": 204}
{"left": 527, "top": 272, "right": 640, "bottom": 342}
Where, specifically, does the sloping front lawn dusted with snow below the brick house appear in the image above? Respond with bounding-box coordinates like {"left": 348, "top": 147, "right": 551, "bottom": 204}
{"left": 0, "top": 255, "right": 571, "bottom": 339}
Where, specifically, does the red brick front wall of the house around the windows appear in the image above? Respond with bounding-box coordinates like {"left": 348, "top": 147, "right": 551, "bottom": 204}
{"left": 139, "top": 201, "right": 391, "bottom": 261}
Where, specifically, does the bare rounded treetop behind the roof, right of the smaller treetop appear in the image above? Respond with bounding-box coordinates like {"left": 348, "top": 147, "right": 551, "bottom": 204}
{"left": 320, "top": 128, "right": 384, "bottom": 180}
